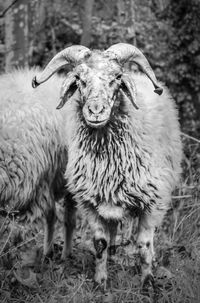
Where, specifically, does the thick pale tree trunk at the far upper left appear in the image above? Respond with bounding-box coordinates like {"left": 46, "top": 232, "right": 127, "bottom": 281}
{"left": 5, "top": 0, "right": 28, "bottom": 71}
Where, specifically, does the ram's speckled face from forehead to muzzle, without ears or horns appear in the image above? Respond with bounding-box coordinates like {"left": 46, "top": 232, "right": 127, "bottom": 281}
{"left": 78, "top": 65, "right": 122, "bottom": 128}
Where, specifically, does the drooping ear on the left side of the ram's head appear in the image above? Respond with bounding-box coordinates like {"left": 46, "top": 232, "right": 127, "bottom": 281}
{"left": 56, "top": 75, "right": 77, "bottom": 109}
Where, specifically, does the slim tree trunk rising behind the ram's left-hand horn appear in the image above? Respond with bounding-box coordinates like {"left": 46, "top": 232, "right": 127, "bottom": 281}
{"left": 81, "top": 0, "right": 94, "bottom": 47}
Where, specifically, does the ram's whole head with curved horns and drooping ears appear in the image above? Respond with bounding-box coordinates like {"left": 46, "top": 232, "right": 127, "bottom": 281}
{"left": 32, "top": 43, "right": 162, "bottom": 128}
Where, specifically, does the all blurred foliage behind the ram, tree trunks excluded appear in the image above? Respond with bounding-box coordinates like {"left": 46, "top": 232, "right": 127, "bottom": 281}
{"left": 25, "top": 0, "right": 200, "bottom": 137}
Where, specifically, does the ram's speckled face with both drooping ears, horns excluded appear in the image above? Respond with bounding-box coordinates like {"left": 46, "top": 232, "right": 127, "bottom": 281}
{"left": 58, "top": 53, "right": 137, "bottom": 128}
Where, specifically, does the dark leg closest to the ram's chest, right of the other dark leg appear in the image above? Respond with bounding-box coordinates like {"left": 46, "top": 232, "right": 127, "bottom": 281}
{"left": 61, "top": 194, "right": 76, "bottom": 260}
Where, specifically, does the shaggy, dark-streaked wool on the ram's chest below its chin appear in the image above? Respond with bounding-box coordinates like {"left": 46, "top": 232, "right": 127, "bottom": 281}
{"left": 65, "top": 123, "right": 159, "bottom": 218}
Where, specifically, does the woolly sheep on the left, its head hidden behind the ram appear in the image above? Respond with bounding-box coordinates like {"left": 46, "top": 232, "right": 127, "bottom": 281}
{"left": 0, "top": 69, "right": 67, "bottom": 255}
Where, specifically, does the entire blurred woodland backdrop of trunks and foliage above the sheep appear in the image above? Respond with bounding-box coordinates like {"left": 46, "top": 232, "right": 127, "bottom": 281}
{"left": 0, "top": 0, "right": 200, "bottom": 138}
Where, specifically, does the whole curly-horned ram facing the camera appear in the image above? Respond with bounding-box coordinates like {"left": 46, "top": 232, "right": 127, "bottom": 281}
{"left": 32, "top": 43, "right": 182, "bottom": 285}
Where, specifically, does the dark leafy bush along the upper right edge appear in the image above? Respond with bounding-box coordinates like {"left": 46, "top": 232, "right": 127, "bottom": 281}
{"left": 157, "top": 0, "right": 200, "bottom": 136}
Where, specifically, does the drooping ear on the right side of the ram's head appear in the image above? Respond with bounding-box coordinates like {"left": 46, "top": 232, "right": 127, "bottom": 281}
{"left": 120, "top": 75, "right": 139, "bottom": 109}
